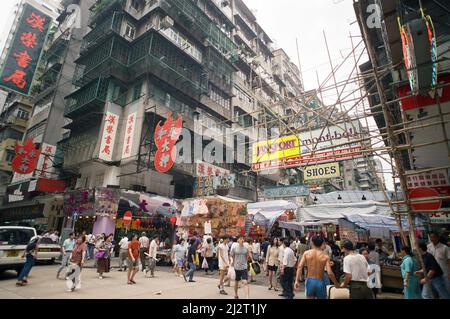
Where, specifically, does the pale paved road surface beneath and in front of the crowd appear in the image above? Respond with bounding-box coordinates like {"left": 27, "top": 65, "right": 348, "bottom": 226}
{"left": 0, "top": 259, "right": 401, "bottom": 299}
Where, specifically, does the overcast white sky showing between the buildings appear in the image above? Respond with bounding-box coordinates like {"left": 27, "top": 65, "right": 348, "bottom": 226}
{"left": 0, "top": 0, "right": 393, "bottom": 189}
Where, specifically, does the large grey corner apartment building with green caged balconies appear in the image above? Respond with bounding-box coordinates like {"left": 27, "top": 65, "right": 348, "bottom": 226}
{"left": 58, "top": 0, "right": 304, "bottom": 204}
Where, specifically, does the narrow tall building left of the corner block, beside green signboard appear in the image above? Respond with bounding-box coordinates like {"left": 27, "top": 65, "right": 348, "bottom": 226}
{"left": 0, "top": 0, "right": 93, "bottom": 228}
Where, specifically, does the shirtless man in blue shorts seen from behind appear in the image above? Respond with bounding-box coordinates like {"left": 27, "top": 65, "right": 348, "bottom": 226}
{"left": 295, "top": 236, "right": 339, "bottom": 299}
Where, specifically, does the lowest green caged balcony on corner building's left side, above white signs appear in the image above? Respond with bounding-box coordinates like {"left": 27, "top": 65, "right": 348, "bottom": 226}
{"left": 64, "top": 77, "right": 109, "bottom": 118}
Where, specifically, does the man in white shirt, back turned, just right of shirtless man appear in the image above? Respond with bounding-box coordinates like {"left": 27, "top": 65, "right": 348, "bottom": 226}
{"left": 341, "top": 240, "right": 373, "bottom": 299}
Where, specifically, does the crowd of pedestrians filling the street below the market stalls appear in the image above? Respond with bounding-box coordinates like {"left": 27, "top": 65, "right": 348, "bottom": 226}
{"left": 12, "top": 232, "right": 450, "bottom": 299}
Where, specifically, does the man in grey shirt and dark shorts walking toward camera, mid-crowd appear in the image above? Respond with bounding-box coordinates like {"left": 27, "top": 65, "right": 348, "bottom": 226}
{"left": 231, "top": 236, "right": 253, "bottom": 299}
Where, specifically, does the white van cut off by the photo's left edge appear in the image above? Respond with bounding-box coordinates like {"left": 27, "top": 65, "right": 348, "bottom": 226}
{"left": 0, "top": 226, "right": 37, "bottom": 272}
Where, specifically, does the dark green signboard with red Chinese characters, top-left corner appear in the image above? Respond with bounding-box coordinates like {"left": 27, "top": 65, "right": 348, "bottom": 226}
{"left": 0, "top": 4, "right": 52, "bottom": 95}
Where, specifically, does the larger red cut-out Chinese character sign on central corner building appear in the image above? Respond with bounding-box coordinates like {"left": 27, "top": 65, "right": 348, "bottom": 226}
{"left": 155, "top": 112, "right": 183, "bottom": 173}
